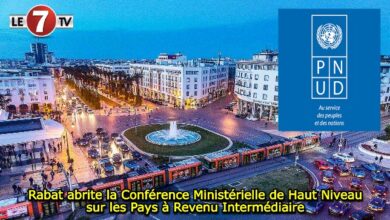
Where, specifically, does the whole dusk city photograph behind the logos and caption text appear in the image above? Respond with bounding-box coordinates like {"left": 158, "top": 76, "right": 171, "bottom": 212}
{"left": 0, "top": 0, "right": 390, "bottom": 220}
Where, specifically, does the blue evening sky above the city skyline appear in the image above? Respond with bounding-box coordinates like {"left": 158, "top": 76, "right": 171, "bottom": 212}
{"left": 0, "top": 0, "right": 390, "bottom": 59}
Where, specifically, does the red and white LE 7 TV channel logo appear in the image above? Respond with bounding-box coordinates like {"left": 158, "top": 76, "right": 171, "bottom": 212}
{"left": 9, "top": 5, "right": 73, "bottom": 37}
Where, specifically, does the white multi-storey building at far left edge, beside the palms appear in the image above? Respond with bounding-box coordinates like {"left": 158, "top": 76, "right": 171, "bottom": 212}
{"left": 0, "top": 69, "right": 55, "bottom": 113}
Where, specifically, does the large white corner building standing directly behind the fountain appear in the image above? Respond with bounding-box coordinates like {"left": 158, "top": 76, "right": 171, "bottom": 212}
{"left": 130, "top": 54, "right": 228, "bottom": 108}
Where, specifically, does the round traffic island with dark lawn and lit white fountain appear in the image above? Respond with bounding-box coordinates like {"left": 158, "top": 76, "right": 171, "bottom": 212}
{"left": 122, "top": 121, "right": 232, "bottom": 158}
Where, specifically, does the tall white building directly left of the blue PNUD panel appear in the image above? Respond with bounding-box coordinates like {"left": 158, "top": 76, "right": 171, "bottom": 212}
{"left": 234, "top": 51, "right": 278, "bottom": 121}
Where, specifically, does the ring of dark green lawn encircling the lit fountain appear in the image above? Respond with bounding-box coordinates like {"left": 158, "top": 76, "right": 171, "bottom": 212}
{"left": 124, "top": 124, "right": 229, "bottom": 156}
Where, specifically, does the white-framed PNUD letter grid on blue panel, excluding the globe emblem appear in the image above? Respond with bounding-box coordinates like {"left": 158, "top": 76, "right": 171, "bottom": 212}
{"left": 311, "top": 15, "right": 348, "bottom": 99}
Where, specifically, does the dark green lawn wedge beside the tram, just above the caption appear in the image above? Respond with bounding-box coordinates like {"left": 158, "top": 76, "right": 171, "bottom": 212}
{"left": 217, "top": 166, "right": 310, "bottom": 193}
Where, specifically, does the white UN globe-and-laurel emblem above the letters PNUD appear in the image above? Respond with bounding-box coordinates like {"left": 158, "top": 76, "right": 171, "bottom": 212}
{"left": 317, "top": 23, "right": 343, "bottom": 49}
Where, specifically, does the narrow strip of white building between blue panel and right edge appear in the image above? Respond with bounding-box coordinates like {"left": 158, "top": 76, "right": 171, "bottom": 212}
{"left": 380, "top": 56, "right": 390, "bottom": 115}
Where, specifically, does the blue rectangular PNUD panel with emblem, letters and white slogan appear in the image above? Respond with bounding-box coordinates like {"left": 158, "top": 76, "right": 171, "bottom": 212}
{"left": 279, "top": 9, "right": 380, "bottom": 131}
